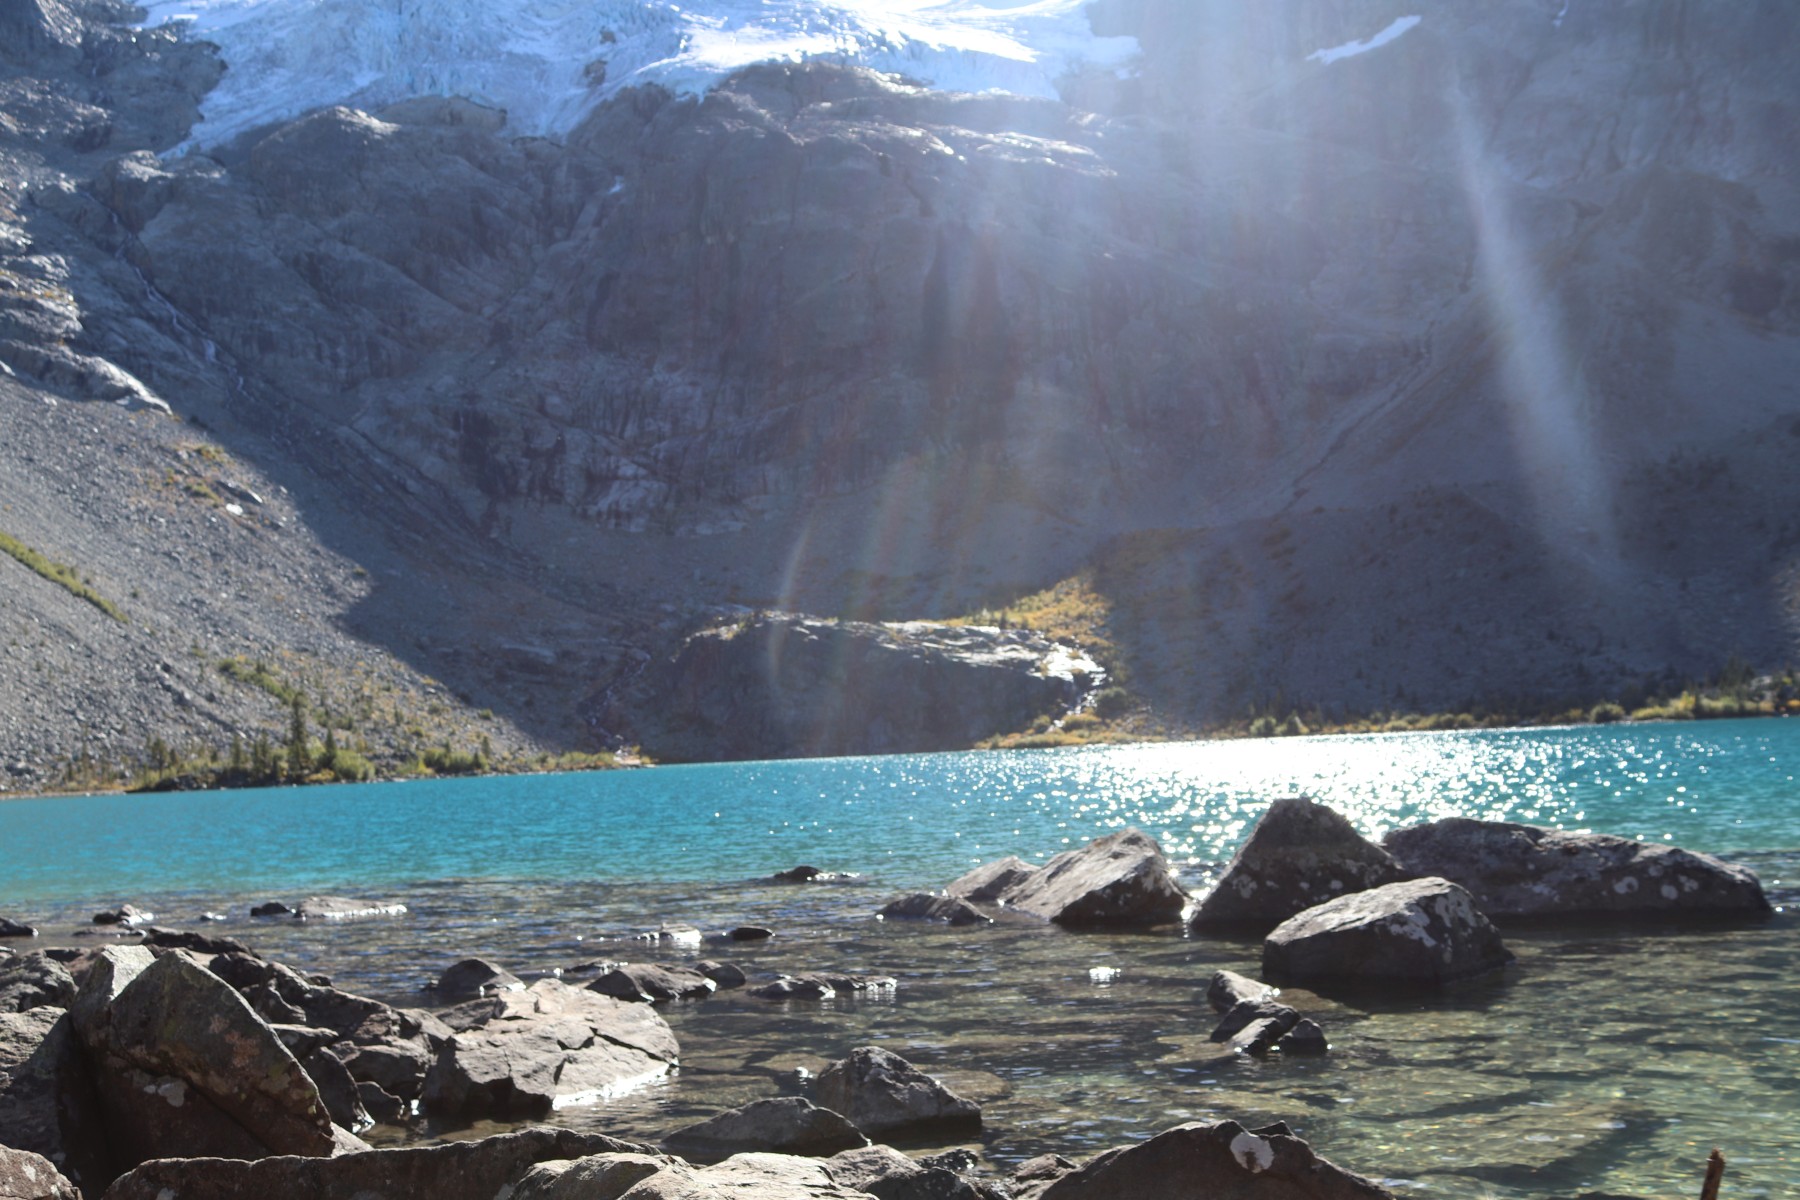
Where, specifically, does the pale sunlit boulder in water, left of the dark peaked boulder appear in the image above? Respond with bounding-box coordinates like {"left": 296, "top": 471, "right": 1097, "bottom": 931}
{"left": 952, "top": 829, "right": 1188, "bottom": 927}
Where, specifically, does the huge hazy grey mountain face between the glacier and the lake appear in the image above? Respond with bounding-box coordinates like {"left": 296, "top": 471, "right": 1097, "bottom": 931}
{"left": 0, "top": 0, "right": 1800, "bottom": 773}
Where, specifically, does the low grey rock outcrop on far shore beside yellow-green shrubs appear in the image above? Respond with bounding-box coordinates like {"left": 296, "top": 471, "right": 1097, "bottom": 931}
{"left": 637, "top": 615, "right": 1100, "bottom": 759}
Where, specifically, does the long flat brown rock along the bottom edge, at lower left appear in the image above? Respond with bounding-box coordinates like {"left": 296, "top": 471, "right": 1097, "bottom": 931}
{"left": 106, "top": 1130, "right": 650, "bottom": 1200}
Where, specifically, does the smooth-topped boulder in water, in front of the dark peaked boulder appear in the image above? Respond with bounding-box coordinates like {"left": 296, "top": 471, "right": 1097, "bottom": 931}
{"left": 1262, "top": 878, "right": 1512, "bottom": 986}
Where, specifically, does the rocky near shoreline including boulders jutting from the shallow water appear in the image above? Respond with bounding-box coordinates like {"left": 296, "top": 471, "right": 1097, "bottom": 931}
{"left": 0, "top": 799, "right": 1768, "bottom": 1200}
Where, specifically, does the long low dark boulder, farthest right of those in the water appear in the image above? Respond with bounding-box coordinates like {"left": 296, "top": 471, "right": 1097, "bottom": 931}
{"left": 1384, "top": 817, "right": 1769, "bottom": 919}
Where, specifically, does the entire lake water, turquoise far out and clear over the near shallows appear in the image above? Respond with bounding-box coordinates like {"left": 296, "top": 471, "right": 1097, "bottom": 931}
{"left": 0, "top": 721, "right": 1800, "bottom": 1200}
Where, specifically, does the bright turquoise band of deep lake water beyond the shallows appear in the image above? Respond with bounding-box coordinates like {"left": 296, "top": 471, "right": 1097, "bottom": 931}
{"left": 0, "top": 720, "right": 1800, "bottom": 909}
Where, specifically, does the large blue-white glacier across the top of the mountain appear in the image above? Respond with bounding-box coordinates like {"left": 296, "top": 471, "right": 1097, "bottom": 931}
{"left": 146, "top": 0, "right": 1137, "bottom": 146}
